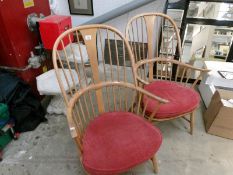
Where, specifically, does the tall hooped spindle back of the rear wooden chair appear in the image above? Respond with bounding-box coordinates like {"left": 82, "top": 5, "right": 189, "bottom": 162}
{"left": 125, "top": 13, "right": 181, "bottom": 81}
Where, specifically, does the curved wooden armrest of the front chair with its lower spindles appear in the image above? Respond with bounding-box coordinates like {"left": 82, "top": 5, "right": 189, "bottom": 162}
{"left": 67, "top": 82, "right": 168, "bottom": 152}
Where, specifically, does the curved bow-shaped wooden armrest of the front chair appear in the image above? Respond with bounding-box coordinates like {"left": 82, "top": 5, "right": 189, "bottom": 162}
{"left": 67, "top": 81, "right": 169, "bottom": 123}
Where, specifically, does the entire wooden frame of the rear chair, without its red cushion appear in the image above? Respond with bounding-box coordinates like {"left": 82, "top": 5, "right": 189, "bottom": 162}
{"left": 126, "top": 13, "right": 209, "bottom": 134}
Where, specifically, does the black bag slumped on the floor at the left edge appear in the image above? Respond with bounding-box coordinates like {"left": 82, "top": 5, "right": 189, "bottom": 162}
{"left": 0, "top": 73, "right": 47, "bottom": 132}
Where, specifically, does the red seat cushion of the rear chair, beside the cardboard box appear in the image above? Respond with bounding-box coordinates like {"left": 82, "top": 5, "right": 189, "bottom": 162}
{"left": 143, "top": 81, "right": 200, "bottom": 119}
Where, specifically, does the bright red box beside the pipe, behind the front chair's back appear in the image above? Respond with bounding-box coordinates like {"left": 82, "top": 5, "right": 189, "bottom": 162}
{"left": 39, "top": 15, "right": 73, "bottom": 50}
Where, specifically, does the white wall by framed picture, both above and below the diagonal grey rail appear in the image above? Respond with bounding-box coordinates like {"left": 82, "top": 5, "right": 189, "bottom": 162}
{"left": 50, "top": 0, "right": 165, "bottom": 28}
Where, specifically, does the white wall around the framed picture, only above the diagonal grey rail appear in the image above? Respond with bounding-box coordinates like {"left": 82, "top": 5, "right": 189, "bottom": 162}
{"left": 50, "top": 0, "right": 133, "bottom": 26}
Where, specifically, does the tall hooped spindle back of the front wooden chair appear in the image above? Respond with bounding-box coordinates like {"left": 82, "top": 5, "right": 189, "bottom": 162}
{"left": 52, "top": 24, "right": 140, "bottom": 145}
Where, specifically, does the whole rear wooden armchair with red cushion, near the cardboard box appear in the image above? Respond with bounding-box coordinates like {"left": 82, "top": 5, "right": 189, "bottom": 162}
{"left": 126, "top": 13, "right": 208, "bottom": 134}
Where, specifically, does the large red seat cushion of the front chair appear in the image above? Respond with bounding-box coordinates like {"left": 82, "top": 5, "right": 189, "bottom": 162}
{"left": 83, "top": 112, "right": 162, "bottom": 175}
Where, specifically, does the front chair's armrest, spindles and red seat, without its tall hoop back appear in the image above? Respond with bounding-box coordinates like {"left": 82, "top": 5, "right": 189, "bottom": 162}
{"left": 67, "top": 82, "right": 166, "bottom": 175}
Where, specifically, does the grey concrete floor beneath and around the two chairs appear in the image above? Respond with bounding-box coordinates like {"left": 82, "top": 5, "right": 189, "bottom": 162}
{"left": 0, "top": 99, "right": 233, "bottom": 175}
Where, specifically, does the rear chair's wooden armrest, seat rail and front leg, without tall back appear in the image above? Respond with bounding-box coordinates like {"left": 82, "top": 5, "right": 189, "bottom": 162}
{"left": 135, "top": 58, "right": 209, "bottom": 134}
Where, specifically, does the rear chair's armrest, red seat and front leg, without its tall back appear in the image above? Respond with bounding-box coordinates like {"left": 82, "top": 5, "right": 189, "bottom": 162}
{"left": 135, "top": 58, "right": 209, "bottom": 134}
